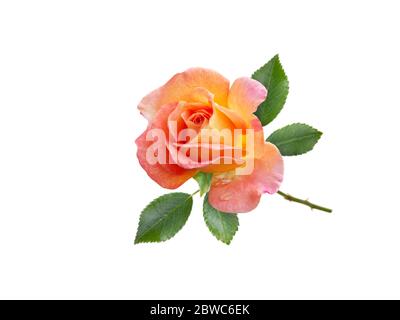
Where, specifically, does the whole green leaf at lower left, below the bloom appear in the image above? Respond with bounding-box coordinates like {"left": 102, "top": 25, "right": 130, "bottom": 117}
{"left": 135, "top": 192, "right": 193, "bottom": 244}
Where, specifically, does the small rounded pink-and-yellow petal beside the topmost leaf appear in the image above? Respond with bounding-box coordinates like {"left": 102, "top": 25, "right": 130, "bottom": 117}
{"left": 228, "top": 78, "right": 267, "bottom": 118}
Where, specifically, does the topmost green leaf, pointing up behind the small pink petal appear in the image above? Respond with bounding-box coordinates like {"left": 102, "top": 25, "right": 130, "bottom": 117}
{"left": 252, "top": 55, "right": 289, "bottom": 126}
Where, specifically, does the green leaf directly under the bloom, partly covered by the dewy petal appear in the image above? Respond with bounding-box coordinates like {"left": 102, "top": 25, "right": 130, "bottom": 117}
{"left": 203, "top": 195, "right": 239, "bottom": 244}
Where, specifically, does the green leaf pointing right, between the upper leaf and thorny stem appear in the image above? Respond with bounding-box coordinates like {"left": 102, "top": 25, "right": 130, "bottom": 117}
{"left": 267, "top": 123, "right": 322, "bottom": 156}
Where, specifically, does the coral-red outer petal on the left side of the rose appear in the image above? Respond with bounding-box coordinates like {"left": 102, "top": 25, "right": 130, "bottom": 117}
{"left": 135, "top": 104, "right": 196, "bottom": 189}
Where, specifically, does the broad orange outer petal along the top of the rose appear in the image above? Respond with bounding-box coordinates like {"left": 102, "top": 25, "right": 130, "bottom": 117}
{"left": 138, "top": 68, "right": 229, "bottom": 121}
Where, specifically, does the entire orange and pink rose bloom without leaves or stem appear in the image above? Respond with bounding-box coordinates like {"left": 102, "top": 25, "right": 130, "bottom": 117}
{"left": 136, "top": 68, "right": 283, "bottom": 213}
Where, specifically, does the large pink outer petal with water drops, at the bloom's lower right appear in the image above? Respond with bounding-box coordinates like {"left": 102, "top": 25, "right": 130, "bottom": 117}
{"left": 208, "top": 142, "right": 283, "bottom": 213}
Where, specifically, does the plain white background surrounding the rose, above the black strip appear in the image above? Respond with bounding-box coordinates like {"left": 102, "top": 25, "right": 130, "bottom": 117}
{"left": 0, "top": 0, "right": 400, "bottom": 299}
